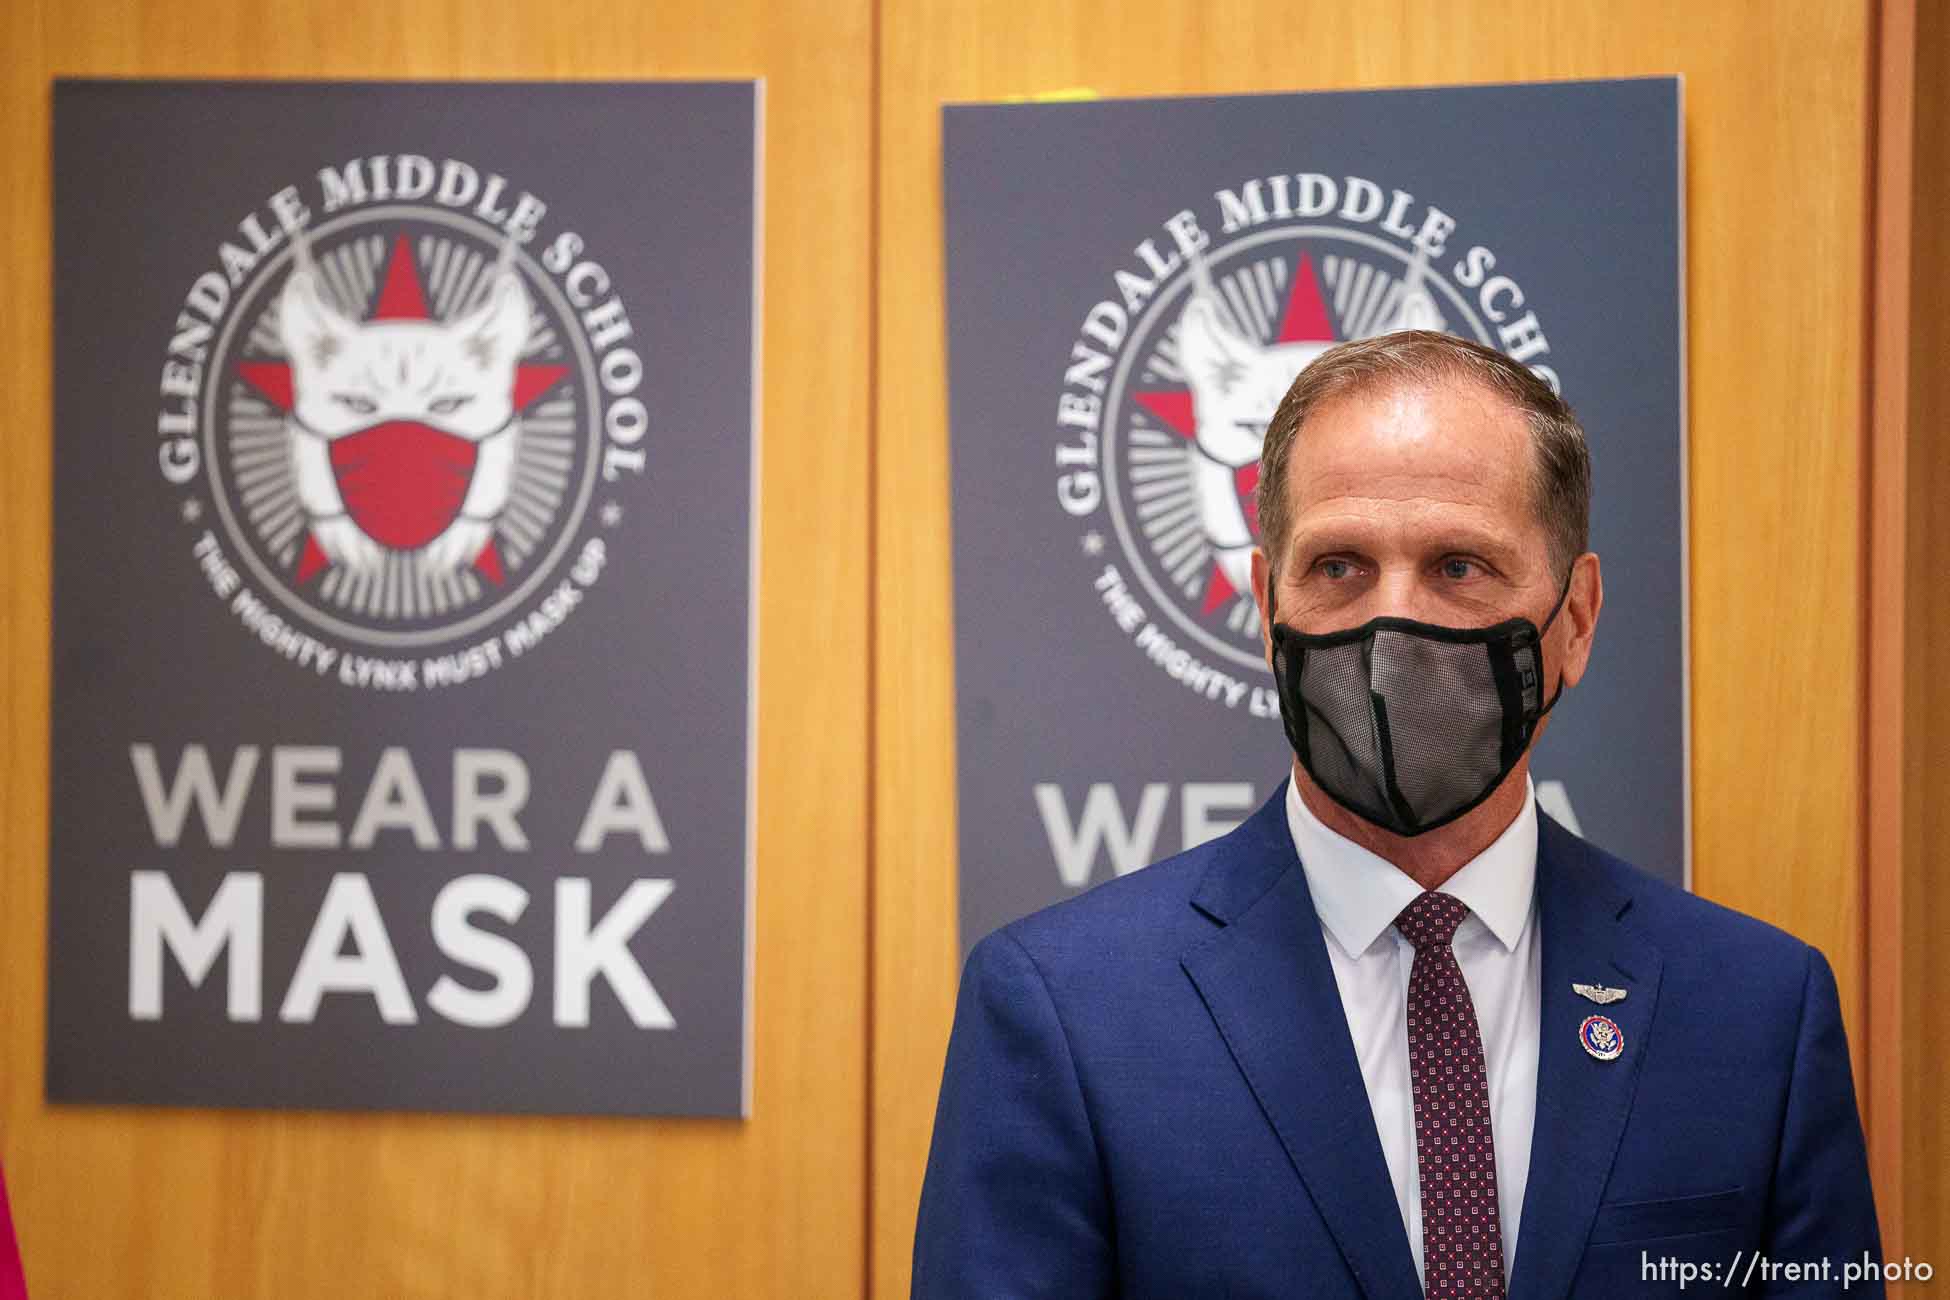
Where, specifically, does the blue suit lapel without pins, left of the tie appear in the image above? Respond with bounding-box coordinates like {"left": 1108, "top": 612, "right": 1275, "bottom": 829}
{"left": 1184, "top": 784, "right": 1422, "bottom": 1300}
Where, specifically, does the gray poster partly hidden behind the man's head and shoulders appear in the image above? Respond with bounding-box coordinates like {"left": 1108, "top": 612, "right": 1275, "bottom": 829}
{"left": 944, "top": 78, "right": 1689, "bottom": 949}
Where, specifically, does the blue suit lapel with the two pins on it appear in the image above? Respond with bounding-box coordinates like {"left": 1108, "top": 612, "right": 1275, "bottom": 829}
{"left": 1509, "top": 815, "right": 1661, "bottom": 1300}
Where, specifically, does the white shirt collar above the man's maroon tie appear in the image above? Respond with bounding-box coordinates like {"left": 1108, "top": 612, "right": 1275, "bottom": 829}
{"left": 1287, "top": 776, "right": 1537, "bottom": 957}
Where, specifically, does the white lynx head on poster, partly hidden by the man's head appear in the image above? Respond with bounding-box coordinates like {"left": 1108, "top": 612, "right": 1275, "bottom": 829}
{"left": 1178, "top": 259, "right": 1443, "bottom": 591}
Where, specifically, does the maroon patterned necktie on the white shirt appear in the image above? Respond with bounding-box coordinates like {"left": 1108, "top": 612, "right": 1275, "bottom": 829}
{"left": 1394, "top": 891, "right": 1503, "bottom": 1300}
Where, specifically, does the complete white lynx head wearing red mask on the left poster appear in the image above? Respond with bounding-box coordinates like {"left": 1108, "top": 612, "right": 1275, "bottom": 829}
{"left": 277, "top": 242, "right": 530, "bottom": 577}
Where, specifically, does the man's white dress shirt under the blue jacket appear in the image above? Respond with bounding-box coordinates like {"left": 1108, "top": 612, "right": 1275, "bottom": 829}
{"left": 1287, "top": 778, "right": 1542, "bottom": 1281}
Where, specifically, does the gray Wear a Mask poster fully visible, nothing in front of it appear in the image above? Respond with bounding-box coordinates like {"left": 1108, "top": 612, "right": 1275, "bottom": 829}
{"left": 47, "top": 82, "right": 759, "bottom": 1115}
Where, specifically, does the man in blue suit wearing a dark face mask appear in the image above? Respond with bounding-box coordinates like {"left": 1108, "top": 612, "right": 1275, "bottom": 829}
{"left": 915, "top": 331, "right": 1882, "bottom": 1300}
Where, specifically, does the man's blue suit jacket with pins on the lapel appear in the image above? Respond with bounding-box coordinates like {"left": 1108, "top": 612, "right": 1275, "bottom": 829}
{"left": 915, "top": 785, "right": 1882, "bottom": 1300}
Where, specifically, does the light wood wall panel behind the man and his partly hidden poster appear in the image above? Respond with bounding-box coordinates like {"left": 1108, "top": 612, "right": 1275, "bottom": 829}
{"left": 872, "top": 0, "right": 1870, "bottom": 1298}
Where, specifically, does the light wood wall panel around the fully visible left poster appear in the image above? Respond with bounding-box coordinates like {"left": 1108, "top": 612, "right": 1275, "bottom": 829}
{"left": 0, "top": 0, "right": 872, "bottom": 1300}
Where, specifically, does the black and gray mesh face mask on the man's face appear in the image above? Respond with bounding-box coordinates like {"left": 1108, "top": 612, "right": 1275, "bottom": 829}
{"left": 1266, "top": 573, "right": 1570, "bottom": 836}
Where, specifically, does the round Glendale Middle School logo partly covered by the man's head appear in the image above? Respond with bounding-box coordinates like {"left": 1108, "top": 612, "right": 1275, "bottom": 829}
{"left": 1057, "top": 173, "right": 1556, "bottom": 717}
